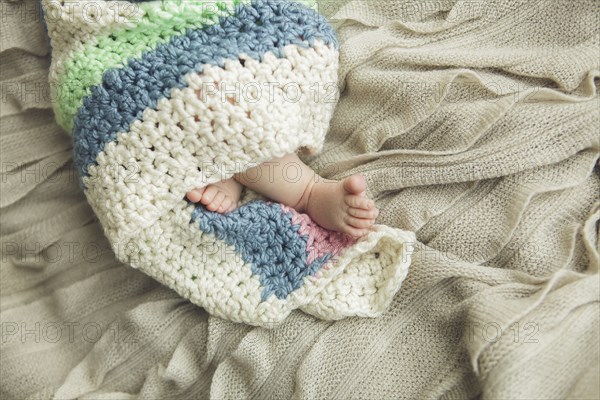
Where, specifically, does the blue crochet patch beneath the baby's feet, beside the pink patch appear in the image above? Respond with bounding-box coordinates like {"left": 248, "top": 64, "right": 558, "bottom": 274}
{"left": 192, "top": 200, "right": 332, "bottom": 301}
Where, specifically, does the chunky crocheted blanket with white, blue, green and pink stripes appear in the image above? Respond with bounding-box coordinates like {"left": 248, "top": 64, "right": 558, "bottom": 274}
{"left": 42, "top": 0, "right": 415, "bottom": 326}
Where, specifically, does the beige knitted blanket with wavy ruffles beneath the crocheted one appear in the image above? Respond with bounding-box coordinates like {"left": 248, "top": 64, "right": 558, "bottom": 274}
{"left": 0, "top": 0, "right": 600, "bottom": 399}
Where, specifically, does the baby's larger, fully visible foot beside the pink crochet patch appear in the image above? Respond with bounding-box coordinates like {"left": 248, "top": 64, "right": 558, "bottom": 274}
{"left": 296, "top": 175, "right": 379, "bottom": 238}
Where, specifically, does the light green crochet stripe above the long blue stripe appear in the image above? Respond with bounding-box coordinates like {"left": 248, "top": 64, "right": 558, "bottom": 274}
{"left": 55, "top": 0, "right": 251, "bottom": 133}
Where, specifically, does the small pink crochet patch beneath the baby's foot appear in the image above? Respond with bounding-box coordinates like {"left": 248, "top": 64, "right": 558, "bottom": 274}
{"left": 281, "top": 204, "right": 356, "bottom": 265}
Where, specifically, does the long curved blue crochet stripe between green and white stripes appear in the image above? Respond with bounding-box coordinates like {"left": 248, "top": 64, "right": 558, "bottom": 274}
{"left": 73, "top": 0, "right": 338, "bottom": 176}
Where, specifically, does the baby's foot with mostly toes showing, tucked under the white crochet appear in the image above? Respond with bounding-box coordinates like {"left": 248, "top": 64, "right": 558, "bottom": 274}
{"left": 186, "top": 178, "right": 242, "bottom": 214}
